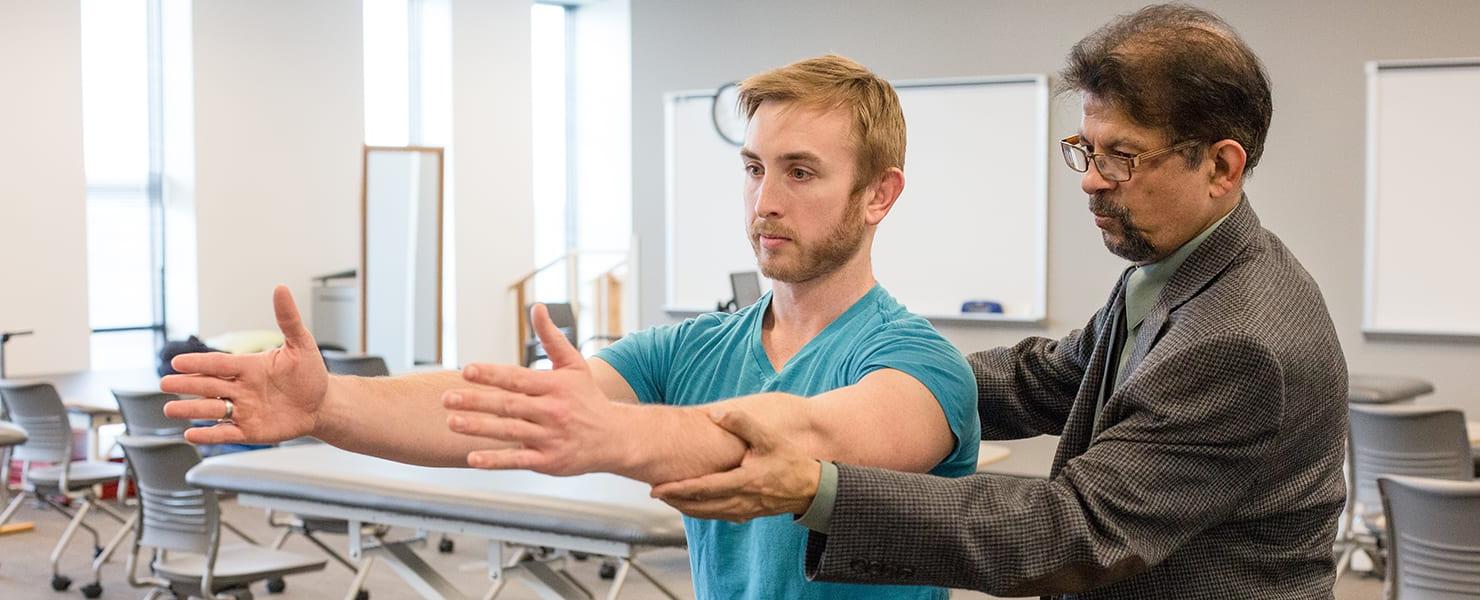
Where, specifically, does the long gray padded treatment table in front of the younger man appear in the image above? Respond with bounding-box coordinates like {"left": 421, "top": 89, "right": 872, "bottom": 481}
{"left": 186, "top": 444, "right": 685, "bottom": 599}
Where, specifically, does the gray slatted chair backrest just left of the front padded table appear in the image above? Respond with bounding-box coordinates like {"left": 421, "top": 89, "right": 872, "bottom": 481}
{"left": 118, "top": 436, "right": 221, "bottom": 554}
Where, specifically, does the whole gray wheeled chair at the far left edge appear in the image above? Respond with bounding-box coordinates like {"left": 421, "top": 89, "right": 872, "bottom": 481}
{"left": 0, "top": 384, "right": 129, "bottom": 599}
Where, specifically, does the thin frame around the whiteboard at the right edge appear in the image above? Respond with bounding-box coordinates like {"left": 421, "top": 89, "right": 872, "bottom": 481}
{"left": 1362, "top": 56, "right": 1480, "bottom": 341}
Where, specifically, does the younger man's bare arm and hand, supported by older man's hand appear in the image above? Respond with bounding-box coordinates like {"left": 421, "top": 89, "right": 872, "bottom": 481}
{"left": 447, "top": 312, "right": 969, "bottom": 483}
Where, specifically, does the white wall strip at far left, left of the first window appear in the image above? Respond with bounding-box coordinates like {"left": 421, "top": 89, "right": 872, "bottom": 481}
{"left": 0, "top": 0, "right": 90, "bottom": 376}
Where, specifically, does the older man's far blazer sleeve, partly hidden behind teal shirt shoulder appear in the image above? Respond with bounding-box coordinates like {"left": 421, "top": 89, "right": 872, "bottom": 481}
{"left": 966, "top": 310, "right": 1106, "bottom": 440}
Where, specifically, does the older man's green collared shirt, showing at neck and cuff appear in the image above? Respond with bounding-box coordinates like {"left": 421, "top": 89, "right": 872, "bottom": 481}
{"left": 796, "top": 210, "right": 1233, "bottom": 533}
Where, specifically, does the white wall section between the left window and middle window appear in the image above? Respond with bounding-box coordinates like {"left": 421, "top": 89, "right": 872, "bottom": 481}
{"left": 190, "top": 0, "right": 364, "bottom": 335}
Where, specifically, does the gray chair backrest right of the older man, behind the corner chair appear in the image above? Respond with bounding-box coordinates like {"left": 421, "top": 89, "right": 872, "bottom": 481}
{"left": 1350, "top": 404, "right": 1474, "bottom": 511}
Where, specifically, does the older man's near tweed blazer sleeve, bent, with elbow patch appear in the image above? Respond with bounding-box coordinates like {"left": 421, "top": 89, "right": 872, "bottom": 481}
{"left": 805, "top": 333, "right": 1283, "bottom": 597}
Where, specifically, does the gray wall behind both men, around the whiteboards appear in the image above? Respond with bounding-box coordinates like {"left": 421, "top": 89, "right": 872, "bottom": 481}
{"left": 632, "top": 0, "right": 1480, "bottom": 418}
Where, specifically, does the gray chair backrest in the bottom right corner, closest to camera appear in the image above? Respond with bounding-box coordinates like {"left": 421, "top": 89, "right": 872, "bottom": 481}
{"left": 1378, "top": 477, "right": 1480, "bottom": 600}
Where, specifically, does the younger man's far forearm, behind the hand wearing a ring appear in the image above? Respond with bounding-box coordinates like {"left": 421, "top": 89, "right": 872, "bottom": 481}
{"left": 312, "top": 370, "right": 502, "bottom": 467}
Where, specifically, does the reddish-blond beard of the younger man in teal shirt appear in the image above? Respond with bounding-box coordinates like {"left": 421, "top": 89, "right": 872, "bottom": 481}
{"left": 750, "top": 197, "right": 866, "bottom": 283}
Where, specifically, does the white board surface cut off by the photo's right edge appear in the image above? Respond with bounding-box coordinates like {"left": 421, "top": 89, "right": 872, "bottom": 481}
{"left": 1361, "top": 59, "right": 1480, "bottom": 336}
